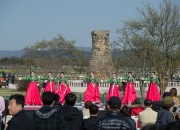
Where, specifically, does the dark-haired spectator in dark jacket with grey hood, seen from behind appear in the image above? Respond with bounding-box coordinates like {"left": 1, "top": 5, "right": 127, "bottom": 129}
{"left": 34, "top": 91, "right": 67, "bottom": 130}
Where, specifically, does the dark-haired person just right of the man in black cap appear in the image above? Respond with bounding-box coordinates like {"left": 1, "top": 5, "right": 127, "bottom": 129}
{"left": 120, "top": 105, "right": 136, "bottom": 130}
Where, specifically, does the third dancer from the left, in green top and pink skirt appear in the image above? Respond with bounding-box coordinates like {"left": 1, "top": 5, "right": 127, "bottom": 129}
{"left": 56, "top": 72, "right": 71, "bottom": 104}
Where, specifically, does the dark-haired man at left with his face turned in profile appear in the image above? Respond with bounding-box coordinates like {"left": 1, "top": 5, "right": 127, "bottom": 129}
{"left": 7, "top": 94, "right": 35, "bottom": 130}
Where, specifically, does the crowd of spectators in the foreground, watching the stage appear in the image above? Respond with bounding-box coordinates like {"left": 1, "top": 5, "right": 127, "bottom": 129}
{"left": 0, "top": 90, "right": 180, "bottom": 130}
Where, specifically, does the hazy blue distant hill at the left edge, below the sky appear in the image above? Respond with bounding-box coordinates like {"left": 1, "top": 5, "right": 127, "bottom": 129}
{"left": 0, "top": 50, "right": 24, "bottom": 58}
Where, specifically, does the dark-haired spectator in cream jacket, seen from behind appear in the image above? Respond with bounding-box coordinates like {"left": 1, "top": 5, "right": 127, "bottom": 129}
{"left": 138, "top": 99, "right": 157, "bottom": 128}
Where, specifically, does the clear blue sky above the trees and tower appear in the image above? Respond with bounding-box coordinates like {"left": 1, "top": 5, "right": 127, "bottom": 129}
{"left": 0, "top": 0, "right": 180, "bottom": 50}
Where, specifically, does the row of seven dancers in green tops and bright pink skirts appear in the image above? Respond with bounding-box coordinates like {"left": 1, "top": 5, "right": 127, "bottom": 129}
{"left": 20, "top": 72, "right": 160, "bottom": 105}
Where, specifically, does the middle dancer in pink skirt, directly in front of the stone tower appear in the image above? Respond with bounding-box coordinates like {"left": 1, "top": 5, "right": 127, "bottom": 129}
{"left": 84, "top": 72, "right": 100, "bottom": 103}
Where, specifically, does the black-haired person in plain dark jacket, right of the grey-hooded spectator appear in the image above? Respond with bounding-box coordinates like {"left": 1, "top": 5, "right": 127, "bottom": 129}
{"left": 62, "top": 93, "right": 83, "bottom": 130}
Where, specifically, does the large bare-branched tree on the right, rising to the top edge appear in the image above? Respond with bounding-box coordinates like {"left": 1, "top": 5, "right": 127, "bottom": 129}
{"left": 118, "top": 0, "right": 180, "bottom": 95}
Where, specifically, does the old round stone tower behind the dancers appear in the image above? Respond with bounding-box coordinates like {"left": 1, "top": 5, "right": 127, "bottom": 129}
{"left": 88, "top": 30, "right": 115, "bottom": 80}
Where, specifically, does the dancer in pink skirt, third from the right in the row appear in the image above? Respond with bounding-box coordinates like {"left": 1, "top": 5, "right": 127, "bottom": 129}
{"left": 104, "top": 73, "right": 121, "bottom": 101}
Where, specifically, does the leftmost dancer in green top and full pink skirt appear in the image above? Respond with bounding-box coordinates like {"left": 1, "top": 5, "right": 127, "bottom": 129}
{"left": 20, "top": 71, "right": 42, "bottom": 105}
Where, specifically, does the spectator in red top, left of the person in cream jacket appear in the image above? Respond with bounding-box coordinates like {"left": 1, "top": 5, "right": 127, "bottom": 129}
{"left": 130, "top": 97, "right": 144, "bottom": 116}
